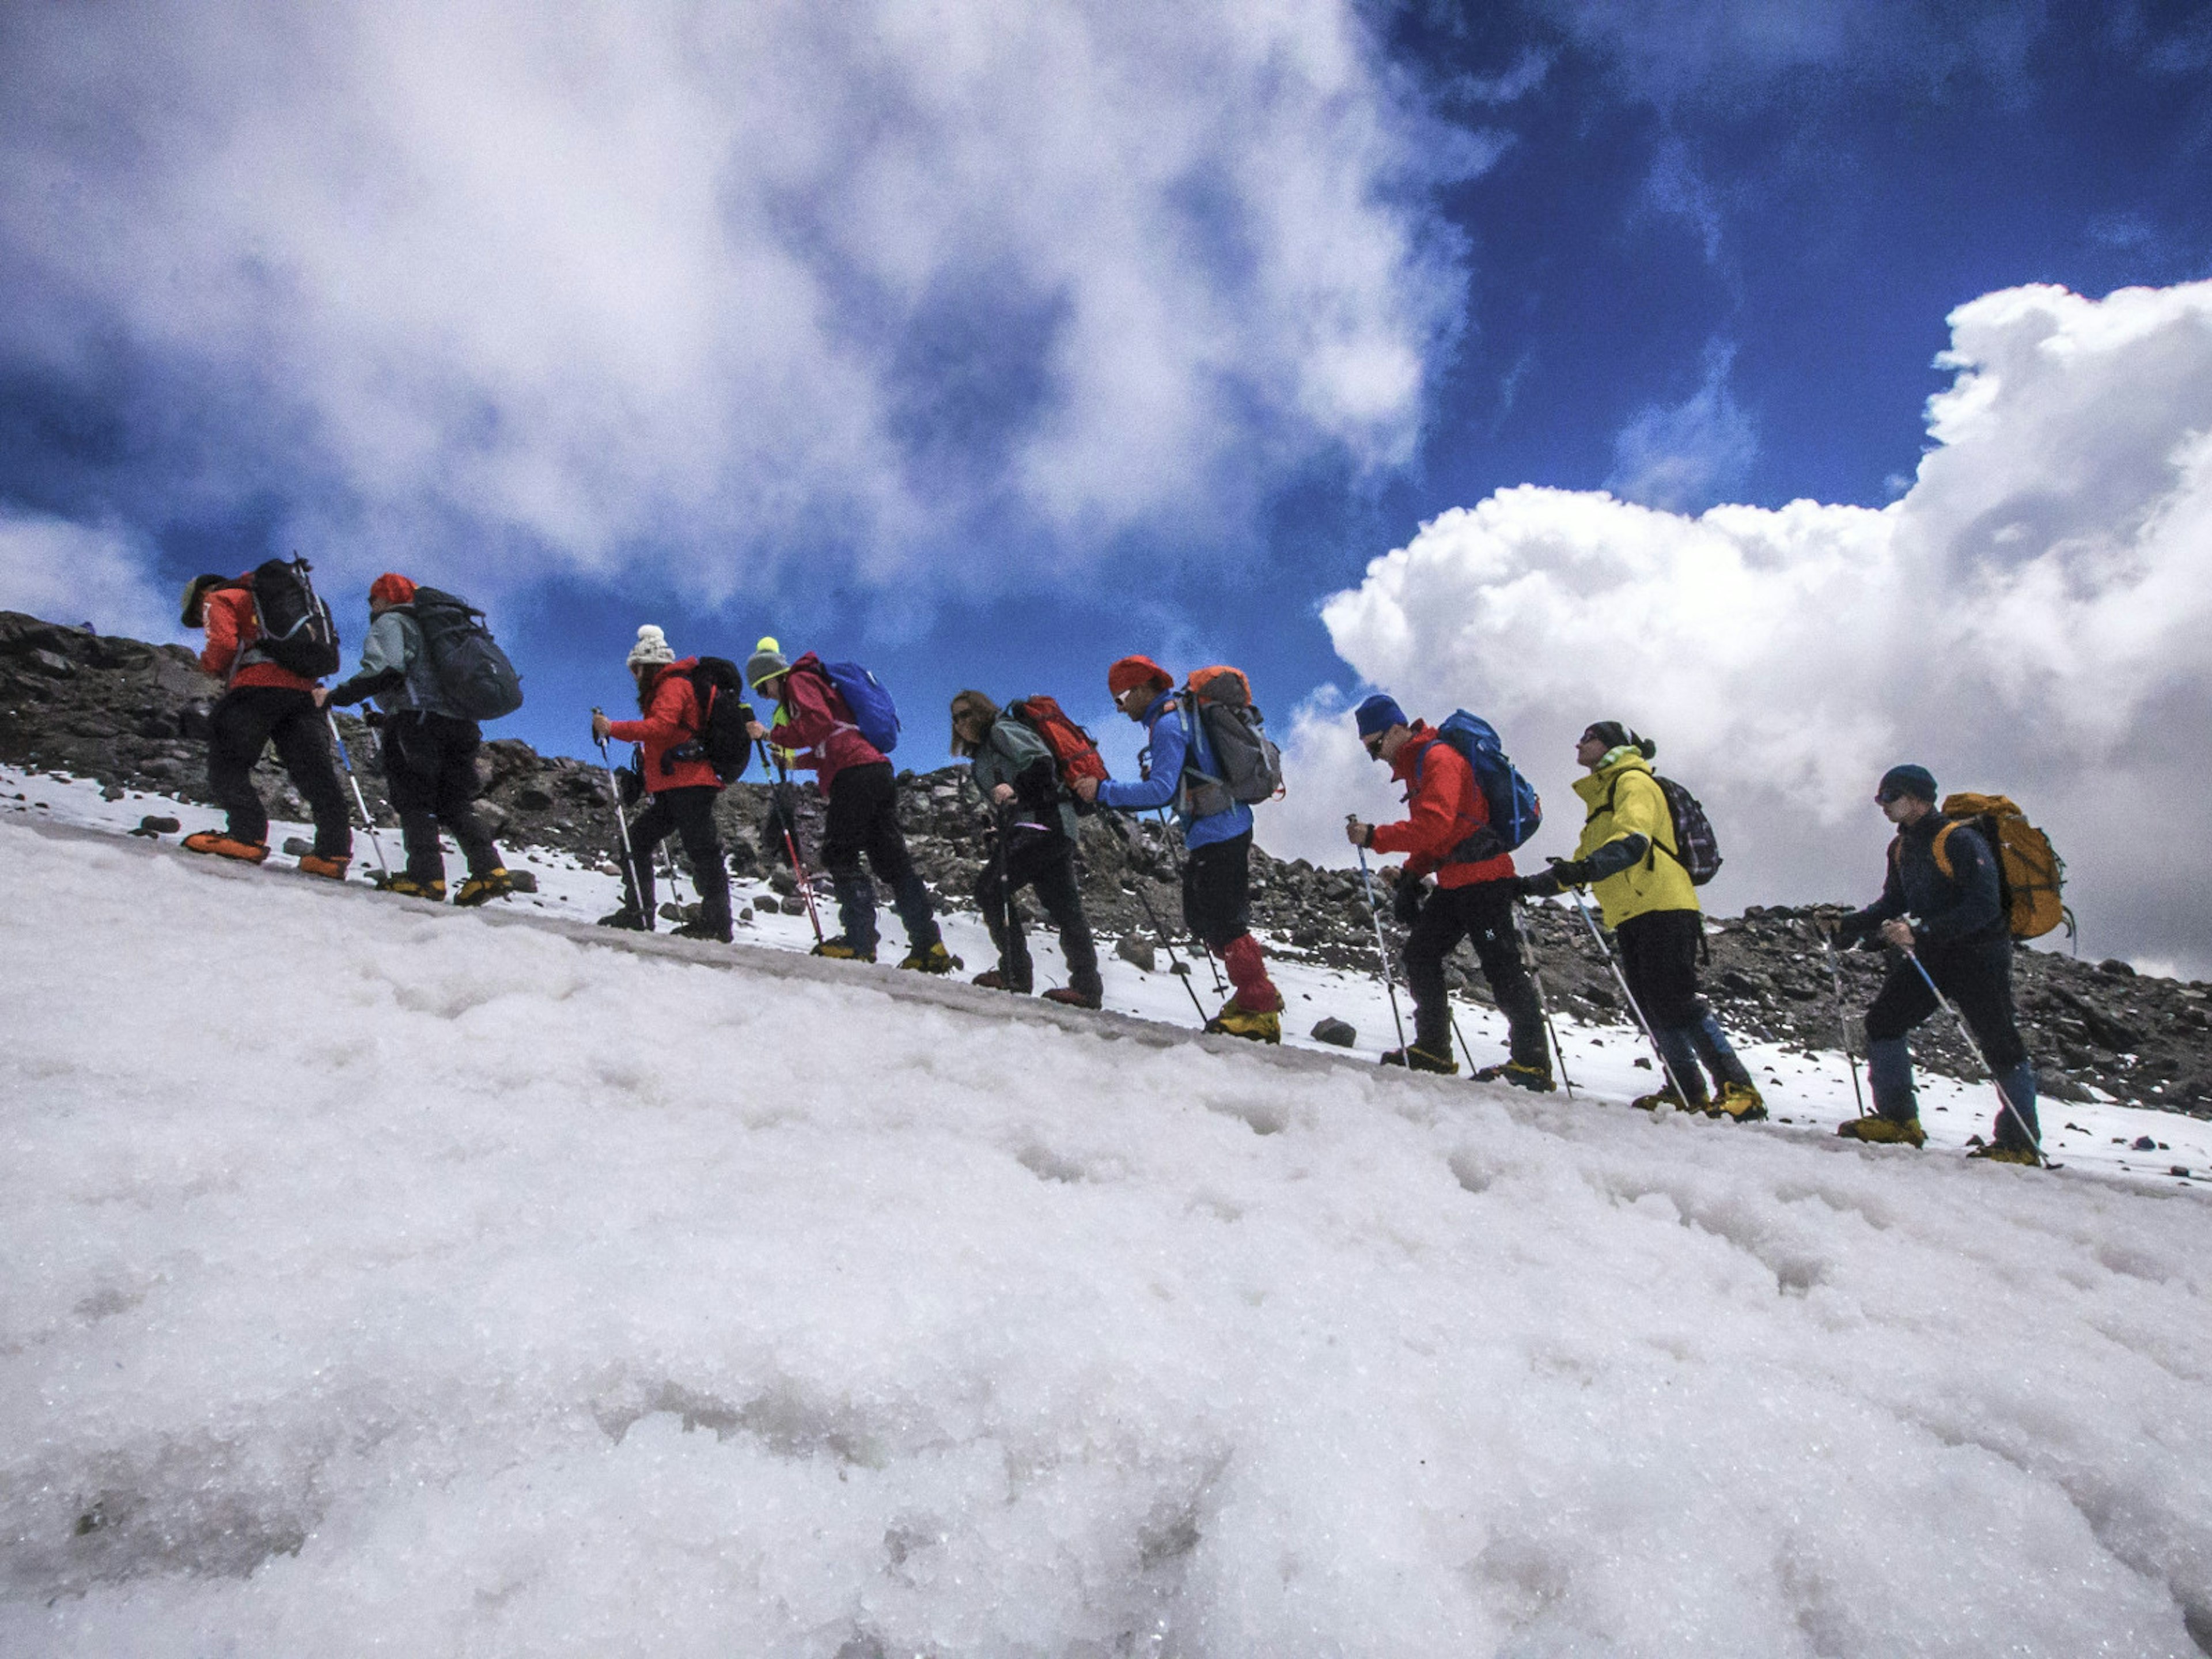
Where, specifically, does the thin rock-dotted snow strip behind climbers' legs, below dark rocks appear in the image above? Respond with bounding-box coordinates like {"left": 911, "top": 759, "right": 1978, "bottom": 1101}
{"left": 0, "top": 766, "right": 2212, "bottom": 1185}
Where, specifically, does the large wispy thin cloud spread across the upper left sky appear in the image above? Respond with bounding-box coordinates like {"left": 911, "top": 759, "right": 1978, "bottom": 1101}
{"left": 0, "top": 0, "right": 1495, "bottom": 595}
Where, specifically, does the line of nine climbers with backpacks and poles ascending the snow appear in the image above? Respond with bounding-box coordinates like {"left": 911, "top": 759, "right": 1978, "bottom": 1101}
{"left": 181, "top": 560, "right": 2057, "bottom": 1164}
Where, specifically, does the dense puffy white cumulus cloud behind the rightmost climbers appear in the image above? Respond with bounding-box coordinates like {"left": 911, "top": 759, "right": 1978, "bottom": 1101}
{"left": 1267, "top": 283, "right": 2212, "bottom": 974}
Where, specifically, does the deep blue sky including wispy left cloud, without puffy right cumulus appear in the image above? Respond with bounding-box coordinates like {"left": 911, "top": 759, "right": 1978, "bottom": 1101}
{"left": 13, "top": 0, "right": 2212, "bottom": 956}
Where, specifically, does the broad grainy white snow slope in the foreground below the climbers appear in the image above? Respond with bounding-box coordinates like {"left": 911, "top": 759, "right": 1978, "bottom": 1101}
{"left": 0, "top": 823, "right": 2212, "bottom": 1659}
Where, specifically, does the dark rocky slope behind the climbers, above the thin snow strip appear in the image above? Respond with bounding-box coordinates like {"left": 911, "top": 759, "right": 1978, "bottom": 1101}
{"left": 0, "top": 613, "right": 2212, "bottom": 1117}
